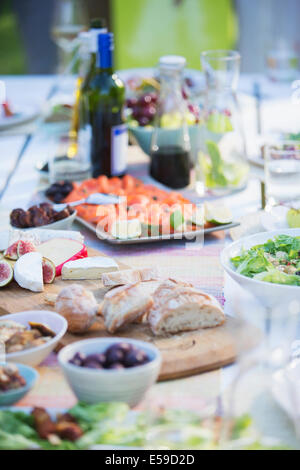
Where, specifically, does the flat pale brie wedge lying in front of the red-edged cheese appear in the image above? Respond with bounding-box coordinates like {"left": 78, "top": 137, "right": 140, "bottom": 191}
{"left": 61, "top": 256, "right": 119, "bottom": 280}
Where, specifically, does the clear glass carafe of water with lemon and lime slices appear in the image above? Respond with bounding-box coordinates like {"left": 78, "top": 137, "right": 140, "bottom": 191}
{"left": 196, "top": 51, "right": 249, "bottom": 195}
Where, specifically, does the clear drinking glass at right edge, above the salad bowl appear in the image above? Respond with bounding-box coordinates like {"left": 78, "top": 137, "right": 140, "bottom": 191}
{"left": 264, "top": 141, "right": 300, "bottom": 206}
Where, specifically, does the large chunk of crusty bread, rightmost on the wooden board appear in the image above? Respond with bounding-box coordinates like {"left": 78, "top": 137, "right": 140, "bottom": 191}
{"left": 148, "top": 279, "right": 225, "bottom": 335}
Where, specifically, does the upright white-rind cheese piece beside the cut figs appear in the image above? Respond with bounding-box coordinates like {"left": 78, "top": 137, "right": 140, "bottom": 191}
{"left": 14, "top": 252, "right": 44, "bottom": 292}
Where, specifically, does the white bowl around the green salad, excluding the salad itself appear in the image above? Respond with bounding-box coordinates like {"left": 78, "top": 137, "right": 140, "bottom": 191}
{"left": 221, "top": 228, "right": 300, "bottom": 308}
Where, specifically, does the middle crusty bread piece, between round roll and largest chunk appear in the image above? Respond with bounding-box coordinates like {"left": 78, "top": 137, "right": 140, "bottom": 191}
{"left": 101, "top": 283, "right": 153, "bottom": 333}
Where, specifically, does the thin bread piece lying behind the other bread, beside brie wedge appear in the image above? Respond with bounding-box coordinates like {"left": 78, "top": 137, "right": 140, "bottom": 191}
{"left": 102, "top": 268, "right": 159, "bottom": 287}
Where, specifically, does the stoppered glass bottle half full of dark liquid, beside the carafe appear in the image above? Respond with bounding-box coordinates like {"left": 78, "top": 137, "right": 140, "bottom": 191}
{"left": 150, "top": 56, "right": 191, "bottom": 189}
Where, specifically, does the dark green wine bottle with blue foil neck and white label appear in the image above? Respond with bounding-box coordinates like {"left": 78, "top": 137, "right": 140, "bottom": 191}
{"left": 87, "top": 33, "right": 128, "bottom": 177}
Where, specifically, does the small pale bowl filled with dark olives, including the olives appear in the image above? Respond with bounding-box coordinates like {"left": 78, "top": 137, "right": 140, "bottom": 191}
{"left": 58, "top": 338, "right": 161, "bottom": 406}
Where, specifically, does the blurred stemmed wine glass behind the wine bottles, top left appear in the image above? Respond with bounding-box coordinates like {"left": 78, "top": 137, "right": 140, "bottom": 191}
{"left": 51, "top": 0, "right": 88, "bottom": 73}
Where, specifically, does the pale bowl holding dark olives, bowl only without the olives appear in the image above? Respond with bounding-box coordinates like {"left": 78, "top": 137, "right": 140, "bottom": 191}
{"left": 58, "top": 338, "right": 161, "bottom": 406}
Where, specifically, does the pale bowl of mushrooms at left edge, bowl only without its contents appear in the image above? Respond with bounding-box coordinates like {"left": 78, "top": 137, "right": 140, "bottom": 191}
{"left": 0, "top": 310, "right": 68, "bottom": 367}
